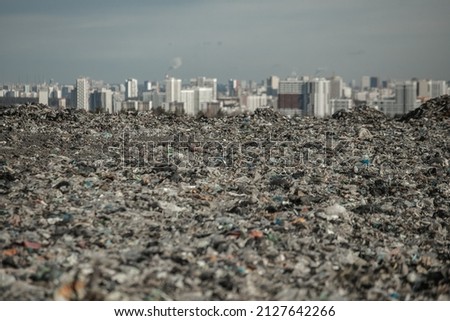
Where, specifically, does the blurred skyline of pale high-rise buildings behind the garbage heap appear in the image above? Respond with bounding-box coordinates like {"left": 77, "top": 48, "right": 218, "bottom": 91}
{"left": 0, "top": 75, "right": 450, "bottom": 117}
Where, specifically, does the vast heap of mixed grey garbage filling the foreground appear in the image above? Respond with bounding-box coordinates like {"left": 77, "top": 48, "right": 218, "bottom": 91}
{"left": 0, "top": 96, "right": 450, "bottom": 300}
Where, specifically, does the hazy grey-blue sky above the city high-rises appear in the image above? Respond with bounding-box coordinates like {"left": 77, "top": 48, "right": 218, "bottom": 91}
{"left": 0, "top": 0, "right": 450, "bottom": 83}
